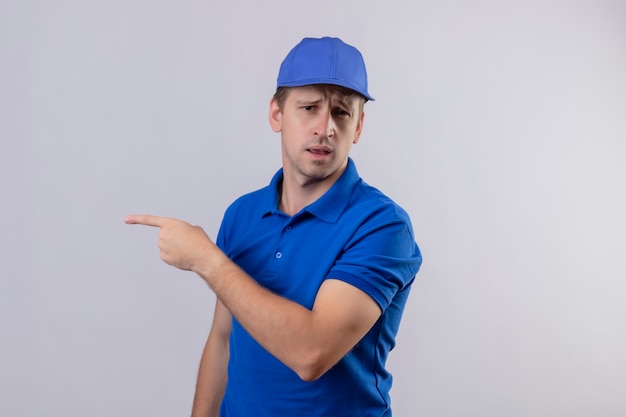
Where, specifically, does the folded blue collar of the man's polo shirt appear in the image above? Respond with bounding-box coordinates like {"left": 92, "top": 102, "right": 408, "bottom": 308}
{"left": 261, "top": 158, "right": 360, "bottom": 223}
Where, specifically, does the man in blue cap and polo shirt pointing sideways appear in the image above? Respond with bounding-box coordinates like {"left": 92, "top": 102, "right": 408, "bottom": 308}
{"left": 126, "top": 37, "right": 421, "bottom": 417}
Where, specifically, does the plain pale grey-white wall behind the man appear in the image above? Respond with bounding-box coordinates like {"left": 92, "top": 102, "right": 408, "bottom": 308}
{"left": 0, "top": 0, "right": 626, "bottom": 417}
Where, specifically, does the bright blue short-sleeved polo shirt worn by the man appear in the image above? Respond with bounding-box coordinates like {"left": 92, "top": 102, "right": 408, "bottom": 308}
{"left": 217, "top": 159, "right": 422, "bottom": 417}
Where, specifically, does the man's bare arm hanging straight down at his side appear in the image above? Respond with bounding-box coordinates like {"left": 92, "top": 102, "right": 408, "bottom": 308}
{"left": 191, "top": 300, "right": 232, "bottom": 417}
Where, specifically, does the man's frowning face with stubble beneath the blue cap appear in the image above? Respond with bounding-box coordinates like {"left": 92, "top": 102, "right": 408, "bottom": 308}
{"left": 270, "top": 86, "right": 364, "bottom": 186}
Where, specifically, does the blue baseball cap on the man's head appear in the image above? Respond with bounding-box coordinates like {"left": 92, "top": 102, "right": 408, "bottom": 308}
{"left": 276, "top": 37, "right": 374, "bottom": 101}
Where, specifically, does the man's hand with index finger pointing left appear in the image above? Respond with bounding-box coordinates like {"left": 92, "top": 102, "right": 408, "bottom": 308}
{"left": 124, "top": 214, "right": 217, "bottom": 272}
